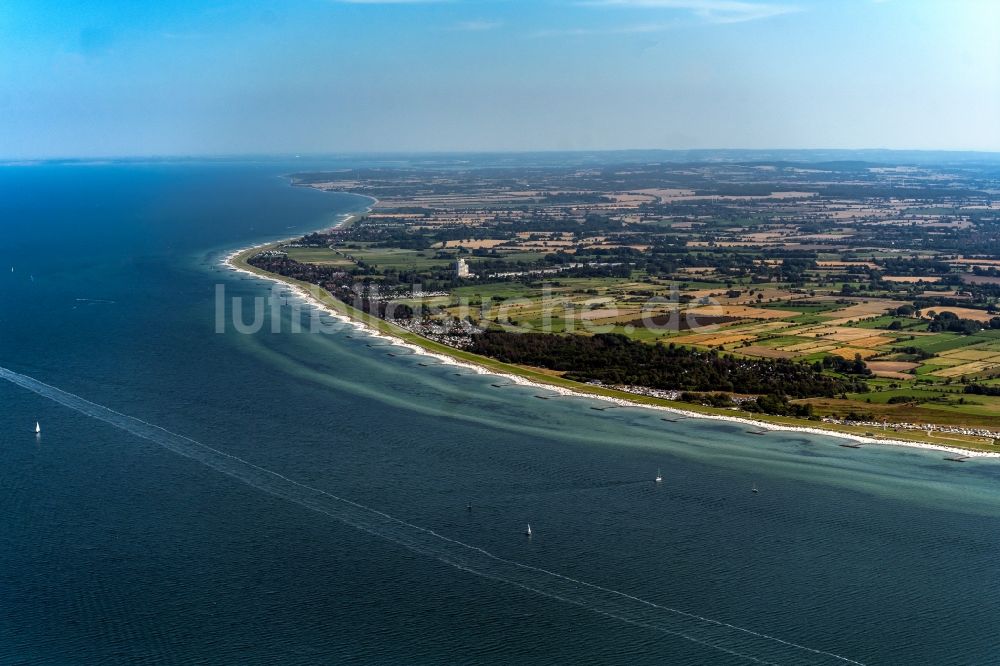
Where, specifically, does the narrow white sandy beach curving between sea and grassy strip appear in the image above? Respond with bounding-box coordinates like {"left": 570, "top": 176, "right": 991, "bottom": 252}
{"left": 222, "top": 226, "right": 1000, "bottom": 458}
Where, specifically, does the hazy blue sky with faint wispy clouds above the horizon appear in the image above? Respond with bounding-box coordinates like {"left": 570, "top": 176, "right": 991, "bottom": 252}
{"left": 0, "top": 0, "right": 1000, "bottom": 158}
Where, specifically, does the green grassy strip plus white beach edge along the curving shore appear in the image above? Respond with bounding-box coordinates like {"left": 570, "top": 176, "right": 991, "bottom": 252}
{"left": 224, "top": 243, "right": 1000, "bottom": 458}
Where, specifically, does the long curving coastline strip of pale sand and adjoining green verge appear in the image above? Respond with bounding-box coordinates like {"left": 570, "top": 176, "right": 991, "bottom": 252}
{"left": 221, "top": 210, "right": 1000, "bottom": 459}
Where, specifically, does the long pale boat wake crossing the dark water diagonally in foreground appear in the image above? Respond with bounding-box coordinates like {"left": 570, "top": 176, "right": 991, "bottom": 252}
{"left": 0, "top": 367, "right": 863, "bottom": 666}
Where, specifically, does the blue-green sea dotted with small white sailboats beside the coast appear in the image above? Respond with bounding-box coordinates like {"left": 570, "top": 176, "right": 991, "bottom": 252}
{"left": 0, "top": 162, "right": 1000, "bottom": 664}
